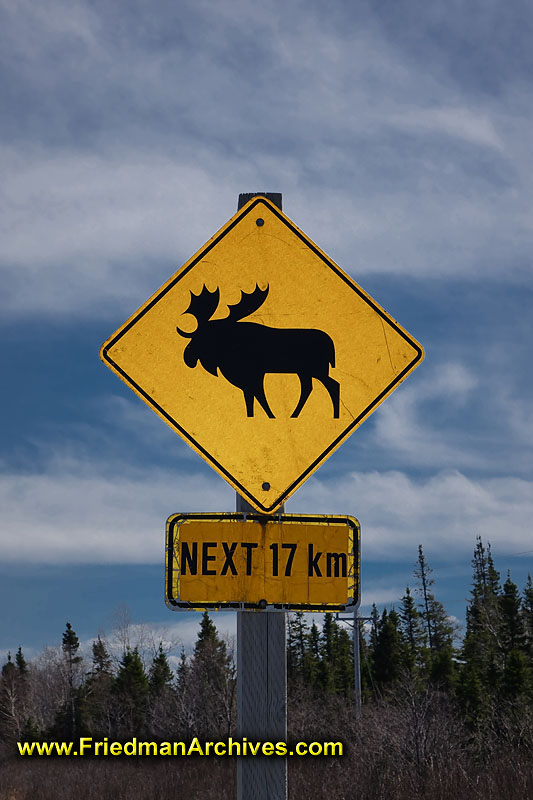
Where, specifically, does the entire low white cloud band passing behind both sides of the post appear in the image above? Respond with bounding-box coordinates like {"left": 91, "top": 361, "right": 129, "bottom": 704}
{"left": 0, "top": 444, "right": 533, "bottom": 564}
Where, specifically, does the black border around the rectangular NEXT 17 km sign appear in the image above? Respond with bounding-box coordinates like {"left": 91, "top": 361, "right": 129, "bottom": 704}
{"left": 165, "top": 511, "right": 361, "bottom": 612}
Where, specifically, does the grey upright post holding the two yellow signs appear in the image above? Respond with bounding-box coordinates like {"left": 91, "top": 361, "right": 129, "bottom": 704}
{"left": 236, "top": 192, "right": 287, "bottom": 800}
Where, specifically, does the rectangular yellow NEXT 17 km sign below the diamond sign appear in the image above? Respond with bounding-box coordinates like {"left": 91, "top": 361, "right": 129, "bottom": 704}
{"left": 165, "top": 512, "right": 360, "bottom": 611}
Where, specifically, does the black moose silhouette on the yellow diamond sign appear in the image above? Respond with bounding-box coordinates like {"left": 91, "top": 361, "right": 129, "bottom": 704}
{"left": 176, "top": 284, "right": 340, "bottom": 419}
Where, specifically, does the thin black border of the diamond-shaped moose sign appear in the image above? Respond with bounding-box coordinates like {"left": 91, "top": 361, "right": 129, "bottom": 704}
{"left": 102, "top": 197, "right": 423, "bottom": 514}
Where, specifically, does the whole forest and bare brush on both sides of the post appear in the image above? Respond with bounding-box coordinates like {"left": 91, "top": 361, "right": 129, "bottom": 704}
{"left": 0, "top": 538, "right": 533, "bottom": 800}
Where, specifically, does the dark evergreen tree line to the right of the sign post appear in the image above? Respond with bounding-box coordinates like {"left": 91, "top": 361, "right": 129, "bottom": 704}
{"left": 288, "top": 538, "right": 533, "bottom": 712}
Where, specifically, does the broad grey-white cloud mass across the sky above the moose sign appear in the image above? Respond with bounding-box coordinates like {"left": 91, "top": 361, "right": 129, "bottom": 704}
{"left": 0, "top": 0, "right": 533, "bottom": 316}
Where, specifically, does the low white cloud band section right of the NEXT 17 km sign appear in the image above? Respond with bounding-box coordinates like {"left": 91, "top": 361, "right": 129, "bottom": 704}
{"left": 287, "top": 470, "right": 533, "bottom": 563}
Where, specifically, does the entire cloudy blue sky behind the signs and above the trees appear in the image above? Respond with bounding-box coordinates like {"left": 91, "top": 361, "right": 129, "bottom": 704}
{"left": 0, "top": 0, "right": 533, "bottom": 656}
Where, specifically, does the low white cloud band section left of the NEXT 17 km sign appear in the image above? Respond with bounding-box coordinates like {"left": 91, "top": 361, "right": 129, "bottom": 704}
{"left": 0, "top": 458, "right": 235, "bottom": 564}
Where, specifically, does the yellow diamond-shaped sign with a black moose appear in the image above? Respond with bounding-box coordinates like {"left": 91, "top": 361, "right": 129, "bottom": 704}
{"left": 100, "top": 197, "right": 423, "bottom": 513}
